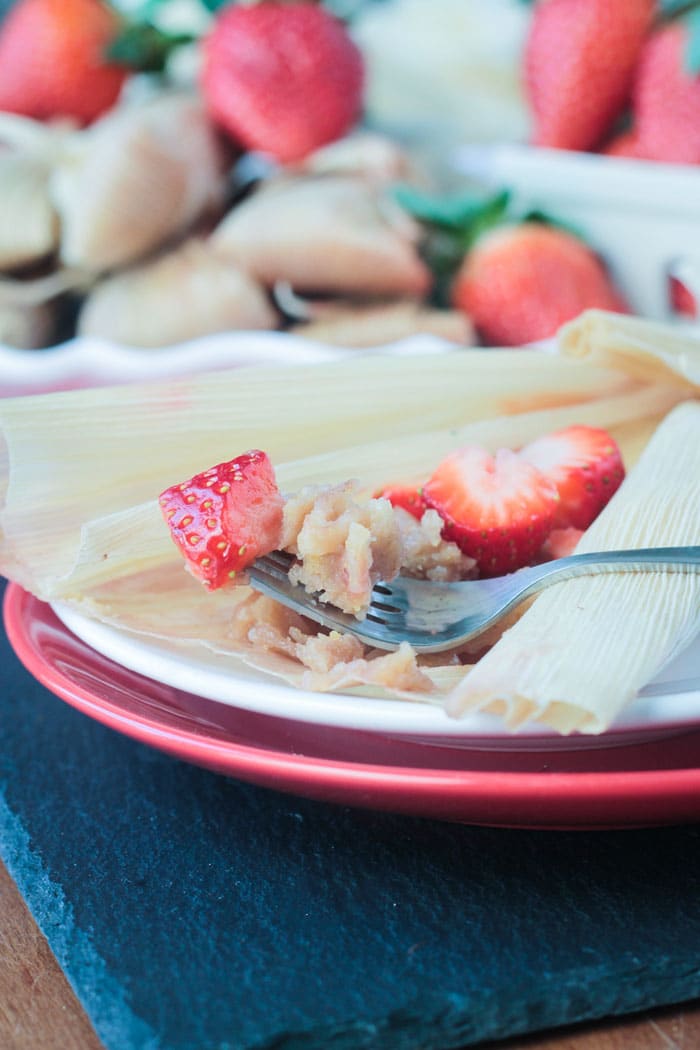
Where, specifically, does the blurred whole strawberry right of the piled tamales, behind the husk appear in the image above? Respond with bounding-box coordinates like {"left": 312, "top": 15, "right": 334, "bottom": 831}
{"left": 452, "top": 223, "right": 627, "bottom": 347}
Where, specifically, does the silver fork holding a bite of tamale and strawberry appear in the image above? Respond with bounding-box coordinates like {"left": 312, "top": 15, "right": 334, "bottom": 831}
{"left": 248, "top": 547, "right": 700, "bottom": 653}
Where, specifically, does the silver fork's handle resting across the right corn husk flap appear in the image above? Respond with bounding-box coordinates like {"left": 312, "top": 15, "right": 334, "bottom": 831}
{"left": 503, "top": 547, "right": 700, "bottom": 600}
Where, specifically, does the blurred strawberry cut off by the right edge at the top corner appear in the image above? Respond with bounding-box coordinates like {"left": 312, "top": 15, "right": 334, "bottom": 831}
{"left": 633, "top": 22, "right": 700, "bottom": 164}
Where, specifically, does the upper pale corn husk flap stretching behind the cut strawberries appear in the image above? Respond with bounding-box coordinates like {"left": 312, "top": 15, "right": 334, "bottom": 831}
{"left": 0, "top": 340, "right": 629, "bottom": 599}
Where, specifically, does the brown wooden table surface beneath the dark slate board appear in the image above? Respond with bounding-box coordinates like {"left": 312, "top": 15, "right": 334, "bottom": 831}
{"left": 0, "top": 864, "right": 700, "bottom": 1050}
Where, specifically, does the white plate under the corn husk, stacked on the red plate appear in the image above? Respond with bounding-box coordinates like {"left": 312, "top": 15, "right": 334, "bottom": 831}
{"left": 52, "top": 603, "right": 700, "bottom": 749}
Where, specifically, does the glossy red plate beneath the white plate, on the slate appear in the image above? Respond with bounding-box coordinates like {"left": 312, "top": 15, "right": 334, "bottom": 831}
{"left": 4, "top": 584, "right": 700, "bottom": 828}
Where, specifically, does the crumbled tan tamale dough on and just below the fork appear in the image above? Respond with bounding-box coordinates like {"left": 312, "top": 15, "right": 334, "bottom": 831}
{"left": 225, "top": 482, "right": 486, "bottom": 692}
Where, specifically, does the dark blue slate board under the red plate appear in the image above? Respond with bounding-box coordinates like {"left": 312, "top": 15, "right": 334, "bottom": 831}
{"left": 0, "top": 579, "right": 700, "bottom": 1050}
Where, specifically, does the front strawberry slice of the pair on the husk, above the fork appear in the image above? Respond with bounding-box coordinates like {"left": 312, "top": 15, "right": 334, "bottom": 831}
{"left": 423, "top": 445, "right": 557, "bottom": 575}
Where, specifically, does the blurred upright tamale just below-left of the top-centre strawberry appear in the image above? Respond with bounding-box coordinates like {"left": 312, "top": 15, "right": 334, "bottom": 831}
{"left": 50, "top": 93, "right": 225, "bottom": 273}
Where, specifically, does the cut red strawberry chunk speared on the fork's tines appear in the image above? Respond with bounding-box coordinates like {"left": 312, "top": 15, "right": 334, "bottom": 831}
{"left": 160, "top": 449, "right": 283, "bottom": 590}
